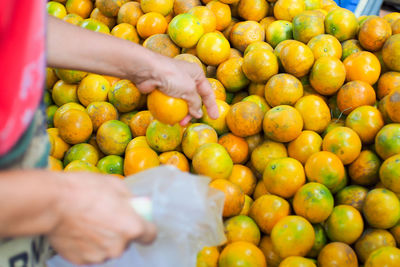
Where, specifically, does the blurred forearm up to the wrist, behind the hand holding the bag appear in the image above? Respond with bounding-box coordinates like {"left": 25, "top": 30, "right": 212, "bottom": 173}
{"left": 0, "top": 170, "right": 63, "bottom": 238}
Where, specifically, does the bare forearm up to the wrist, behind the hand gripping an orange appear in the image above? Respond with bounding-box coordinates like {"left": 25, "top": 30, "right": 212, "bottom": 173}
{"left": 47, "top": 16, "right": 158, "bottom": 79}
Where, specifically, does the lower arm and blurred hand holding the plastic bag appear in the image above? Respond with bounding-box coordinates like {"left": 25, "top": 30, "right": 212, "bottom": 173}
{"left": 0, "top": 170, "right": 155, "bottom": 264}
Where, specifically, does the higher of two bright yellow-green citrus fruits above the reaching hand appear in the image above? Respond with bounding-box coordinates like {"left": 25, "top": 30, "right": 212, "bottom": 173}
{"left": 168, "top": 13, "right": 204, "bottom": 48}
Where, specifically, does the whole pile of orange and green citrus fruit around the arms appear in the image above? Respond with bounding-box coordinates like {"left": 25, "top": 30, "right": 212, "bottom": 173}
{"left": 45, "top": 0, "right": 400, "bottom": 267}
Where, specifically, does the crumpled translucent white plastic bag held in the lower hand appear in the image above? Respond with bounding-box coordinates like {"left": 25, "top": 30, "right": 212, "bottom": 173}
{"left": 48, "top": 166, "right": 225, "bottom": 267}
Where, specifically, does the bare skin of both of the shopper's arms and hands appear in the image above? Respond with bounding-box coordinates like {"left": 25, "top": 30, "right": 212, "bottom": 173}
{"left": 0, "top": 16, "right": 218, "bottom": 265}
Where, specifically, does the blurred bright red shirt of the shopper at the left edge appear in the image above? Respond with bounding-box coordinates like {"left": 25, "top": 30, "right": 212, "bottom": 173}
{"left": 0, "top": 0, "right": 46, "bottom": 155}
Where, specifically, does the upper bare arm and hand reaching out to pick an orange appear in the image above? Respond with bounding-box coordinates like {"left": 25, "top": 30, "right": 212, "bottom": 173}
{"left": 47, "top": 16, "right": 218, "bottom": 123}
